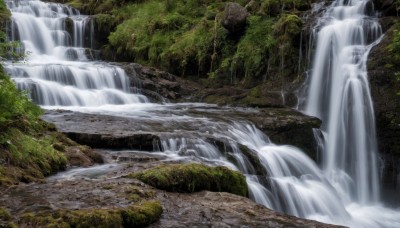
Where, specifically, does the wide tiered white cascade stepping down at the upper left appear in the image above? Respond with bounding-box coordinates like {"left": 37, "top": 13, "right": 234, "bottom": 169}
{"left": 5, "top": 0, "right": 147, "bottom": 106}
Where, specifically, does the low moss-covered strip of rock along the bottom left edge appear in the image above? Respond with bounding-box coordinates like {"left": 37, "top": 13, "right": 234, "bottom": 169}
{"left": 19, "top": 201, "right": 163, "bottom": 228}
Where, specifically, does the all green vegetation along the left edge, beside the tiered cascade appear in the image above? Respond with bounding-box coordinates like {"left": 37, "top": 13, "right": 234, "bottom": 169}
{"left": 0, "top": 0, "right": 73, "bottom": 186}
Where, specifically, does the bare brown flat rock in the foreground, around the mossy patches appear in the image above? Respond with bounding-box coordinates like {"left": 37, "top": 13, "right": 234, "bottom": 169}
{"left": 0, "top": 161, "right": 344, "bottom": 227}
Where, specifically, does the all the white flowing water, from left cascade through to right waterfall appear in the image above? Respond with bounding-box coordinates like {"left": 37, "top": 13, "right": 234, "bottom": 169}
{"left": 6, "top": 0, "right": 400, "bottom": 227}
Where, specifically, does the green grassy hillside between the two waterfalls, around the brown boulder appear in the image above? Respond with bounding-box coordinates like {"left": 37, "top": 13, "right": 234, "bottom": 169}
{"left": 58, "top": 0, "right": 313, "bottom": 86}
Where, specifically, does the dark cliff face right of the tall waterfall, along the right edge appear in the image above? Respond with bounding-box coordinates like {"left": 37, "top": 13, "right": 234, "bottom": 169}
{"left": 368, "top": 0, "right": 400, "bottom": 196}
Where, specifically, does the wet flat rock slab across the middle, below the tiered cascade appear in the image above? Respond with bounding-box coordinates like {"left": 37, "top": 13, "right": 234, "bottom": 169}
{"left": 43, "top": 104, "right": 320, "bottom": 155}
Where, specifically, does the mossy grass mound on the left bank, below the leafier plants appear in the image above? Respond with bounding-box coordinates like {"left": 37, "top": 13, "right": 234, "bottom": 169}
{"left": 0, "top": 128, "right": 67, "bottom": 186}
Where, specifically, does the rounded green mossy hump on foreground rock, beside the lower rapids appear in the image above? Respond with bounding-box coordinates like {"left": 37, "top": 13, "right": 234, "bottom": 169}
{"left": 128, "top": 163, "right": 248, "bottom": 196}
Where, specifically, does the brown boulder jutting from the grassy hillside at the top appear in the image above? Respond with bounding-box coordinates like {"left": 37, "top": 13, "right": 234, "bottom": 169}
{"left": 222, "top": 2, "right": 249, "bottom": 34}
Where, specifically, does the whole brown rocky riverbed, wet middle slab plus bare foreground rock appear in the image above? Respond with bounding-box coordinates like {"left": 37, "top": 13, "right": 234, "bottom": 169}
{"left": 0, "top": 97, "right": 340, "bottom": 227}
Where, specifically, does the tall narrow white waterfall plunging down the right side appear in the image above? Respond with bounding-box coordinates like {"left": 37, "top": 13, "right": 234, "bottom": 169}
{"left": 305, "top": 0, "right": 381, "bottom": 204}
